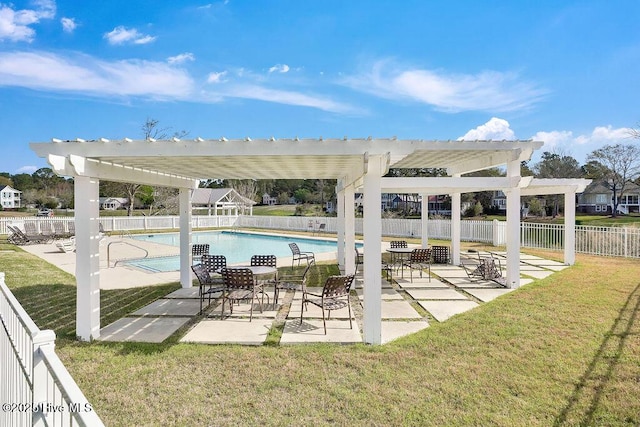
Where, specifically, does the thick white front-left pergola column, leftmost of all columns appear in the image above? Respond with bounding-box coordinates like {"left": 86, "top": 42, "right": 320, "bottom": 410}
{"left": 74, "top": 176, "right": 100, "bottom": 341}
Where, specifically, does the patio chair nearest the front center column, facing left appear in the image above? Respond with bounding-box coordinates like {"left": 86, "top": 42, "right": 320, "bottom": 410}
{"left": 300, "top": 275, "right": 354, "bottom": 335}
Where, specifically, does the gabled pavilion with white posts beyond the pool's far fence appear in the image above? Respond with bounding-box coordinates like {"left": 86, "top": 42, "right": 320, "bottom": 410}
{"left": 191, "top": 188, "right": 256, "bottom": 215}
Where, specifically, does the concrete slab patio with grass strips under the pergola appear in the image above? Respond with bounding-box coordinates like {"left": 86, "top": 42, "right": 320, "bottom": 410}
{"left": 94, "top": 253, "right": 566, "bottom": 345}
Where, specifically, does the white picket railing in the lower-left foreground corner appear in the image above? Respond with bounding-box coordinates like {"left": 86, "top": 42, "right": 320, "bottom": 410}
{"left": 0, "top": 273, "right": 104, "bottom": 427}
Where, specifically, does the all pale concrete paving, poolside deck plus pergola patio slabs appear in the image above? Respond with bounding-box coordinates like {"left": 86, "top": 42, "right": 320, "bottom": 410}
{"left": 18, "top": 237, "right": 567, "bottom": 345}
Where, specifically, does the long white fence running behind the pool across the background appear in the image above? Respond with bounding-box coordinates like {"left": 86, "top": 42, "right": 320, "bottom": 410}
{"left": 0, "top": 215, "right": 640, "bottom": 258}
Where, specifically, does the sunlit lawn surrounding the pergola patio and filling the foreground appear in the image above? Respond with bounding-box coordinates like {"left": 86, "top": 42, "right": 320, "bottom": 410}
{"left": 0, "top": 245, "right": 640, "bottom": 426}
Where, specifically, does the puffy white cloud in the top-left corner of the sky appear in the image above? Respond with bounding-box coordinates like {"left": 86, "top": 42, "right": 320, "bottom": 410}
{"left": 0, "top": 0, "right": 56, "bottom": 42}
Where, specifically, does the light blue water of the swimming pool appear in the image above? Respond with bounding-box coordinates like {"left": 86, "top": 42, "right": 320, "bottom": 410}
{"left": 124, "top": 231, "right": 348, "bottom": 272}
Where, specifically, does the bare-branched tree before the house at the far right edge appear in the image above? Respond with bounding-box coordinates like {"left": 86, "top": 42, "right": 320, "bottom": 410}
{"left": 585, "top": 144, "right": 640, "bottom": 217}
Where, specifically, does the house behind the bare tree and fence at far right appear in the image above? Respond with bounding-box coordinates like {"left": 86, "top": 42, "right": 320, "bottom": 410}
{"left": 576, "top": 181, "right": 640, "bottom": 214}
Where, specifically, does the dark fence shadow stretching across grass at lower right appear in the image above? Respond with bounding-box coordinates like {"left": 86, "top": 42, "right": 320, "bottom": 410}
{"left": 554, "top": 285, "right": 640, "bottom": 426}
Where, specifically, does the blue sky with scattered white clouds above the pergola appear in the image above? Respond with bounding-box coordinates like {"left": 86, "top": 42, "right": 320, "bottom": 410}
{"left": 0, "top": 0, "right": 640, "bottom": 174}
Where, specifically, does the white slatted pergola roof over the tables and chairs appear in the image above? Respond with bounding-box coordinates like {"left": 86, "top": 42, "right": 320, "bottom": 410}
{"left": 30, "top": 138, "right": 543, "bottom": 186}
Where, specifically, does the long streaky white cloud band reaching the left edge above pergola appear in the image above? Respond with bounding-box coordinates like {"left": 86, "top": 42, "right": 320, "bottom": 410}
{"left": 0, "top": 52, "right": 194, "bottom": 99}
